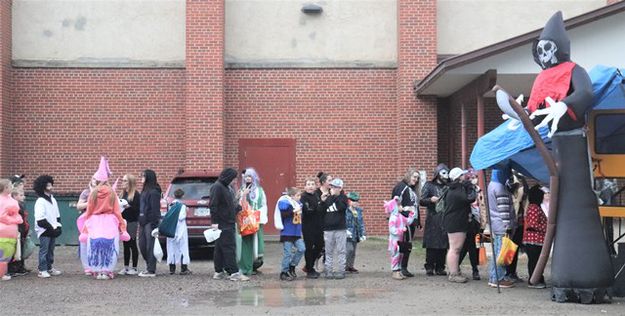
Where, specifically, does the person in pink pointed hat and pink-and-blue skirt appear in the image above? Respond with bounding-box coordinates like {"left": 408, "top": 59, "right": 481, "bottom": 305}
{"left": 79, "top": 159, "right": 130, "bottom": 280}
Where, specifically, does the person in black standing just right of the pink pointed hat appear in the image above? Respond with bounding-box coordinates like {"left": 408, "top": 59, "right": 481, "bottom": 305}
{"left": 119, "top": 174, "right": 140, "bottom": 275}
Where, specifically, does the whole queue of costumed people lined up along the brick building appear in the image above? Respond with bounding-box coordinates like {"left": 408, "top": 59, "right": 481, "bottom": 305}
{"left": 0, "top": 162, "right": 547, "bottom": 288}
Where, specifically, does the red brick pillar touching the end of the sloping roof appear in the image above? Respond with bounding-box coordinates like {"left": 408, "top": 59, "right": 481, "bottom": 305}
{"left": 395, "top": 0, "right": 438, "bottom": 230}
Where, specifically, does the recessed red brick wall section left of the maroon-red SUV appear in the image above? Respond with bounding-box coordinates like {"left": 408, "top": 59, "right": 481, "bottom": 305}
{"left": 11, "top": 69, "right": 185, "bottom": 193}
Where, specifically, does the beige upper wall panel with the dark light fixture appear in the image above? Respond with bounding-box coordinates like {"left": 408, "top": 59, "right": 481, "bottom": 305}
{"left": 226, "top": 0, "right": 397, "bottom": 67}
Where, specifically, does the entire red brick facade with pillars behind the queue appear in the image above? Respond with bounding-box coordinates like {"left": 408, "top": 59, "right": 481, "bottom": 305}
{"left": 0, "top": 0, "right": 616, "bottom": 235}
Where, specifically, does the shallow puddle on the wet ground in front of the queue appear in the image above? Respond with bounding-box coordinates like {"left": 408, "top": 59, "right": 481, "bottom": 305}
{"left": 201, "top": 284, "right": 379, "bottom": 307}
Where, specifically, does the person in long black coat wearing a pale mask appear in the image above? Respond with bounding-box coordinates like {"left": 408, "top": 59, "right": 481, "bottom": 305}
{"left": 419, "top": 164, "right": 449, "bottom": 275}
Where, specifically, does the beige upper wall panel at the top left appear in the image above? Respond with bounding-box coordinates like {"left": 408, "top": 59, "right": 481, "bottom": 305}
{"left": 13, "top": 0, "right": 185, "bottom": 67}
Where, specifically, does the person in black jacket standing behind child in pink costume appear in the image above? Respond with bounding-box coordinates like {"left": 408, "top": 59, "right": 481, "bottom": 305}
{"left": 391, "top": 168, "right": 421, "bottom": 277}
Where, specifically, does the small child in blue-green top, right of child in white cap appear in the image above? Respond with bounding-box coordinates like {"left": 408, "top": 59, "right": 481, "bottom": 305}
{"left": 345, "top": 192, "right": 367, "bottom": 273}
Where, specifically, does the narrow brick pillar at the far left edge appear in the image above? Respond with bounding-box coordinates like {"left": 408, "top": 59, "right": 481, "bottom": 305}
{"left": 0, "top": 1, "right": 12, "bottom": 176}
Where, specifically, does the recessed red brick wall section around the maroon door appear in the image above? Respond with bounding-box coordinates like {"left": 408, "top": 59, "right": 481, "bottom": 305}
{"left": 225, "top": 69, "right": 398, "bottom": 235}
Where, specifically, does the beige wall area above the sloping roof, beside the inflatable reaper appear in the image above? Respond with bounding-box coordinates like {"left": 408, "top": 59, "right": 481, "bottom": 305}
{"left": 437, "top": 0, "right": 606, "bottom": 54}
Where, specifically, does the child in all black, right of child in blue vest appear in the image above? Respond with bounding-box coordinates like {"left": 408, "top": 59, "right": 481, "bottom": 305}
{"left": 300, "top": 177, "right": 324, "bottom": 279}
